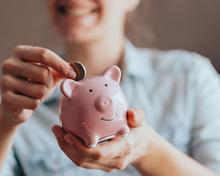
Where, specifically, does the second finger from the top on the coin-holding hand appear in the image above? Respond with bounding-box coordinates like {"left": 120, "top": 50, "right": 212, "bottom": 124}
{"left": 2, "top": 58, "right": 53, "bottom": 87}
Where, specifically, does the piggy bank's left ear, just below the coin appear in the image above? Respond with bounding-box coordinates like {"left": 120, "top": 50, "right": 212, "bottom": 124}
{"left": 60, "top": 79, "right": 79, "bottom": 98}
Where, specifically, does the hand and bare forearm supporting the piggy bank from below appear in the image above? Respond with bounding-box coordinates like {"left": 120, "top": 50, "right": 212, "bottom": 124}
{"left": 53, "top": 110, "right": 217, "bottom": 176}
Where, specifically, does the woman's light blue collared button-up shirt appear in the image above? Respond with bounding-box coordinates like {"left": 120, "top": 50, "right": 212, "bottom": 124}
{"left": 1, "top": 43, "right": 220, "bottom": 176}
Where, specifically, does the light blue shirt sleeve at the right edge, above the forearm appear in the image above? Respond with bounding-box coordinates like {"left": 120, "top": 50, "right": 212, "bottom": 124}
{"left": 190, "top": 55, "right": 220, "bottom": 173}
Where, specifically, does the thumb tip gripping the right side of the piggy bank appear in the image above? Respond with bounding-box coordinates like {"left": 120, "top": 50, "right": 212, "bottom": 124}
{"left": 127, "top": 109, "right": 145, "bottom": 128}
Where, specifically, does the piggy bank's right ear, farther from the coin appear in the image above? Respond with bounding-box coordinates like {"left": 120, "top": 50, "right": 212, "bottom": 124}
{"left": 103, "top": 65, "right": 121, "bottom": 83}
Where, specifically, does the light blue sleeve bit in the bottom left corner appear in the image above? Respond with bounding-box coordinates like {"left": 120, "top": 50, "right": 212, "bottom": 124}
{"left": 0, "top": 150, "right": 20, "bottom": 176}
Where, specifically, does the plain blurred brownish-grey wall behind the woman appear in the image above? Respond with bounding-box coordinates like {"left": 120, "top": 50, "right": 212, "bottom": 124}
{"left": 0, "top": 0, "right": 220, "bottom": 72}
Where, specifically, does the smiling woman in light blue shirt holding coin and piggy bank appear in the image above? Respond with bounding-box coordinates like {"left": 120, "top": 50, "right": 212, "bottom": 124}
{"left": 0, "top": 0, "right": 220, "bottom": 176}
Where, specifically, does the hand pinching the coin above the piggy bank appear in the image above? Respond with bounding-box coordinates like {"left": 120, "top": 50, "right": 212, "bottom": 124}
{"left": 0, "top": 46, "right": 75, "bottom": 126}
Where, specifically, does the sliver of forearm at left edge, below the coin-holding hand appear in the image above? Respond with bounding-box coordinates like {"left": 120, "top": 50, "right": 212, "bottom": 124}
{"left": 0, "top": 116, "right": 17, "bottom": 170}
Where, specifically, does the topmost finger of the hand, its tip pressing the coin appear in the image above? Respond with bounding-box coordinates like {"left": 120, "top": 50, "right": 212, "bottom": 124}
{"left": 14, "top": 45, "right": 76, "bottom": 79}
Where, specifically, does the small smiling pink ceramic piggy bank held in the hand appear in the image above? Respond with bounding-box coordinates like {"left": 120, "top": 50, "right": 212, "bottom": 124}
{"left": 60, "top": 66, "right": 129, "bottom": 147}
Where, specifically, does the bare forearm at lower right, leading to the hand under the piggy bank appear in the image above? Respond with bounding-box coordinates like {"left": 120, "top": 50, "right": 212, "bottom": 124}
{"left": 134, "top": 129, "right": 216, "bottom": 176}
